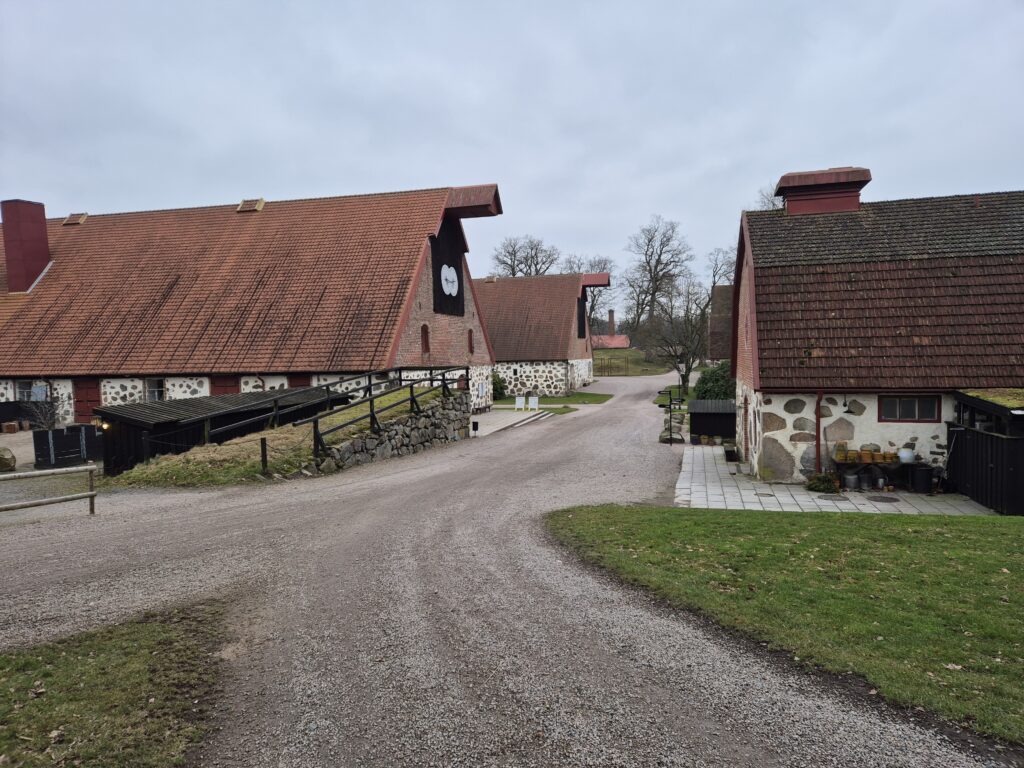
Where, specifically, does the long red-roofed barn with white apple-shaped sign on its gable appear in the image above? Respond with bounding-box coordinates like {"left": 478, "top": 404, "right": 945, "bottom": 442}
{"left": 0, "top": 185, "right": 502, "bottom": 422}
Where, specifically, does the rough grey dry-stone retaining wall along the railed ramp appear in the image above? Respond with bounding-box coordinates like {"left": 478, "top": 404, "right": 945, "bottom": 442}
{"left": 317, "top": 391, "right": 473, "bottom": 473}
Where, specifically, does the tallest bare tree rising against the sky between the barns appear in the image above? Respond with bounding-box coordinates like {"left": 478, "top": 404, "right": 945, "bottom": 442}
{"left": 625, "top": 215, "right": 693, "bottom": 326}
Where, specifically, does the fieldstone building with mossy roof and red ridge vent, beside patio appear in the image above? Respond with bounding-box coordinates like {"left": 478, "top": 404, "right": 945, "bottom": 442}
{"left": 733, "top": 168, "right": 1024, "bottom": 498}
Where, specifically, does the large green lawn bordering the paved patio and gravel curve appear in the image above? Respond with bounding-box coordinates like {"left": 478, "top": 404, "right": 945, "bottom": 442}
{"left": 548, "top": 506, "right": 1024, "bottom": 743}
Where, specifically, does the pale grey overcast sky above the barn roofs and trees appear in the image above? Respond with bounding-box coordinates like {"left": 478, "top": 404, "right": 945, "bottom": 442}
{"left": 0, "top": 0, "right": 1024, "bottom": 294}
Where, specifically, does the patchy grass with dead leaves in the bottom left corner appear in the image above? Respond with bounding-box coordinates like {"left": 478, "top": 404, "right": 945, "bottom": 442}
{"left": 0, "top": 604, "right": 221, "bottom": 768}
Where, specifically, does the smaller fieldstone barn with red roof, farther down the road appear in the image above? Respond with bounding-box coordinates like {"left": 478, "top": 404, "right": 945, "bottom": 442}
{"left": 473, "top": 272, "right": 610, "bottom": 395}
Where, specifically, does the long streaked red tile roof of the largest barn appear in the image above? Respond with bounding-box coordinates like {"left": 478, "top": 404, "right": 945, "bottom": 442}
{"left": 0, "top": 186, "right": 500, "bottom": 376}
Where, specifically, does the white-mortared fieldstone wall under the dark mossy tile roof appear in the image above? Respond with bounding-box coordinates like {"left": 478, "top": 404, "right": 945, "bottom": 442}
{"left": 736, "top": 384, "right": 955, "bottom": 482}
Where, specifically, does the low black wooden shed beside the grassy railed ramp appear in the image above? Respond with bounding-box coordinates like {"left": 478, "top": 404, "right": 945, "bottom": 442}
{"left": 93, "top": 387, "right": 339, "bottom": 476}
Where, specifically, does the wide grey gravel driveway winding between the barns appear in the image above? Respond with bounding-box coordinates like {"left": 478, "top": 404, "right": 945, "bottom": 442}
{"left": 0, "top": 377, "right": 1007, "bottom": 768}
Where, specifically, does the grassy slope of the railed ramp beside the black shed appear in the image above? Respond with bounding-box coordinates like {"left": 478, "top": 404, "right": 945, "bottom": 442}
{"left": 99, "top": 389, "right": 442, "bottom": 487}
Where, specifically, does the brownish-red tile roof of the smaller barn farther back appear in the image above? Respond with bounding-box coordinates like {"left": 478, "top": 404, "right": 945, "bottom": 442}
{"left": 473, "top": 274, "right": 584, "bottom": 362}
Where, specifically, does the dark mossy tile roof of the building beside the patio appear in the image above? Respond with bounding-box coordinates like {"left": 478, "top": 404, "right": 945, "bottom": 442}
{"left": 744, "top": 191, "right": 1024, "bottom": 391}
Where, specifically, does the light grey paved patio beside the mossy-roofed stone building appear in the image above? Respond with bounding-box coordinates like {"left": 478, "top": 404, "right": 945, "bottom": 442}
{"left": 676, "top": 445, "right": 994, "bottom": 515}
